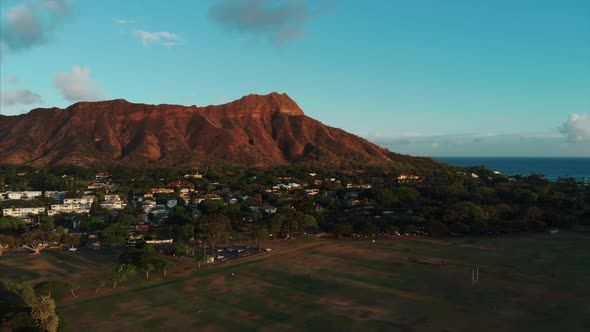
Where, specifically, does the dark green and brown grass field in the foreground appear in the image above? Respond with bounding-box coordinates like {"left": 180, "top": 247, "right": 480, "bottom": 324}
{"left": 0, "top": 233, "right": 590, "bottom": 331}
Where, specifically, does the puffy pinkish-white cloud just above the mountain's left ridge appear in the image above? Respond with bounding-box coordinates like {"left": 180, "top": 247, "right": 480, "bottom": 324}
{"left": 53, "top": 66, "right": 105, "bottom": 102}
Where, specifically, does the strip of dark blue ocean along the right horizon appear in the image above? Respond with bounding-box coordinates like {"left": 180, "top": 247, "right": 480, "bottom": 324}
{"left": 434, "top": 157, "right": 590, "bottom": 182}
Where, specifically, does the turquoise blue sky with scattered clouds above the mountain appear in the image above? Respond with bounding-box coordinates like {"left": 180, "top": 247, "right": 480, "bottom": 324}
{"left": 0, "top": 0, "right": 590, "bottom": 156}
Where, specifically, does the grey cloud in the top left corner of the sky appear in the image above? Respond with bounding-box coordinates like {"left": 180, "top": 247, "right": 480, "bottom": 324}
{"left": 0, "top": 0, "right": 71, "bottom": 52}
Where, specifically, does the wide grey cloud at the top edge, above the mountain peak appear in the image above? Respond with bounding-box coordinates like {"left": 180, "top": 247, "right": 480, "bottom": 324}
{"left": 209, "top": 0, "right": 331, "bottom": 44}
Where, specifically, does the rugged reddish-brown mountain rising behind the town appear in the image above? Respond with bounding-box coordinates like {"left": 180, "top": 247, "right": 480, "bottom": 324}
{"left": 0, "top": 93, "right": 435, "bottom": 167}
